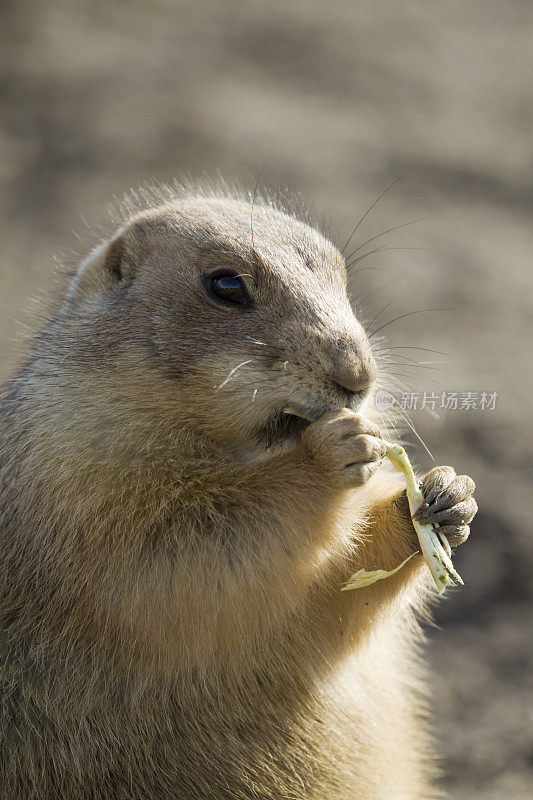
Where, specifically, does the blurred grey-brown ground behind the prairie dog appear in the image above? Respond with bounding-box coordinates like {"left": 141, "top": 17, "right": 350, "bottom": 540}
{"left": 0, "top": 0, "right": 533, "bottom": 800}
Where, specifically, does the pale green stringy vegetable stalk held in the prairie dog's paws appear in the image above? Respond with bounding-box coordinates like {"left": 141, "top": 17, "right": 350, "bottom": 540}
{"left": 342, "top": 442, "right": 463, "bottom": 594}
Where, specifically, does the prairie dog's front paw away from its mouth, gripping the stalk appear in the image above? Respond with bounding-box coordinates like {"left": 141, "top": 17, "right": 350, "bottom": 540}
{"left": 413, "top": 467, "right": 477, "bottom": 547}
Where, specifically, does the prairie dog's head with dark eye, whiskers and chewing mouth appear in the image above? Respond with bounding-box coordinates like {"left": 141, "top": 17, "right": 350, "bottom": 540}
{"left": 57, "top": 197, "right": 377, "bottom": 454}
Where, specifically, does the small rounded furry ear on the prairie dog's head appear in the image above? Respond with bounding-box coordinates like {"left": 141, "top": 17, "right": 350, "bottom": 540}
{"left": 62, "top": 225, "right": 142, "bottom": 310}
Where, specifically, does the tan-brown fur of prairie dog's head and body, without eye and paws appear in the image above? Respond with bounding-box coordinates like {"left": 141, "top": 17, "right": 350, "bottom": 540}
{"left": 0, "top": 189, "right": 434, "bottom": 800}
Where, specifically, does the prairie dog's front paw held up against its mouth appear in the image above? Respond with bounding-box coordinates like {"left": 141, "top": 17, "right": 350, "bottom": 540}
{"left": 302, "top": 408, "right": 386, "bottom": 486}
